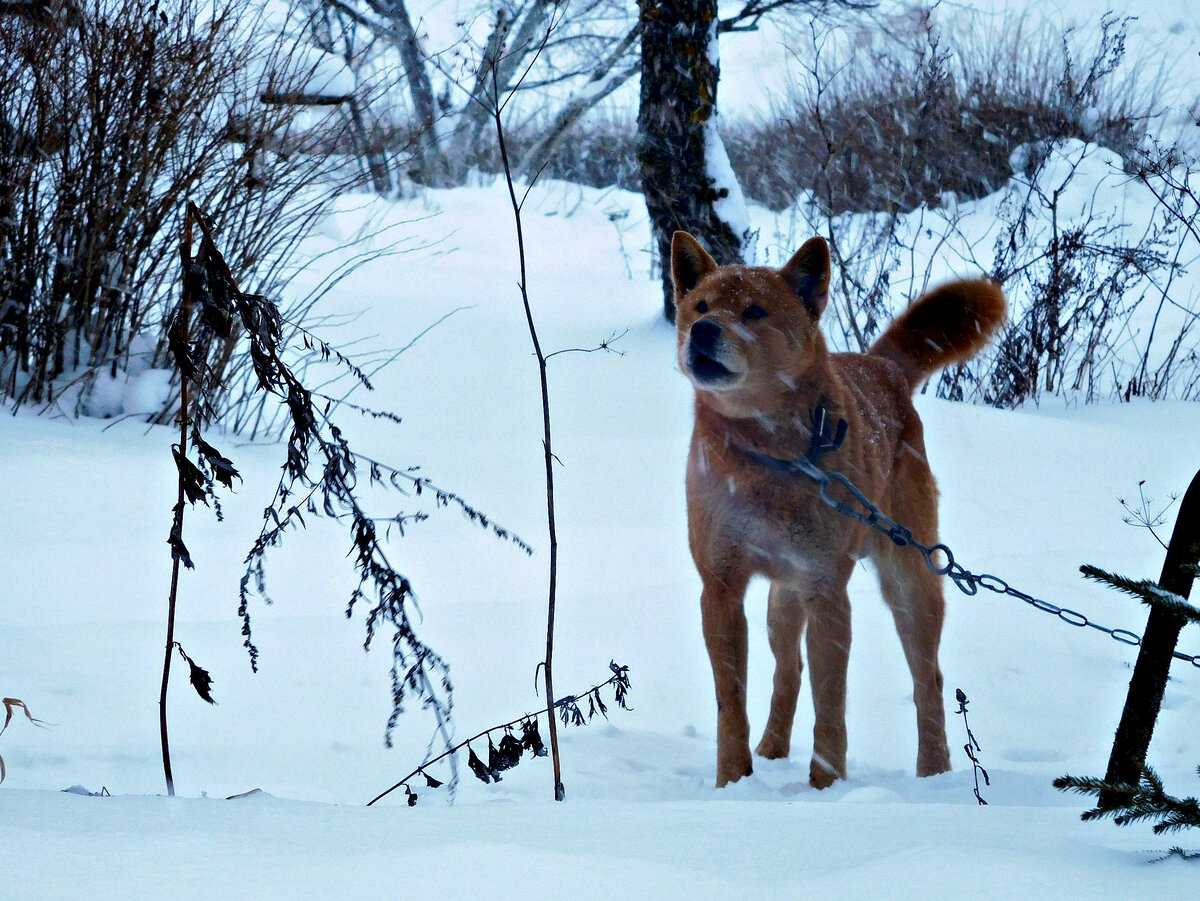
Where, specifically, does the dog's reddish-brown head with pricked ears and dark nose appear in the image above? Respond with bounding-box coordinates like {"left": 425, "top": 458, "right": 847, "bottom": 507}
{"left": 671, "top": 232, "right": 829, "bottom": 416}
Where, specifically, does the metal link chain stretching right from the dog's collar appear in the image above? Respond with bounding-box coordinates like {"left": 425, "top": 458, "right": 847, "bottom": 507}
{"left": 749, "top": 443, "right": 1200, "bottom": 669}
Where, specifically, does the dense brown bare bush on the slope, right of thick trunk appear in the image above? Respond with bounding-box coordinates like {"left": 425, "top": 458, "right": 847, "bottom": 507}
{"left": 726, "top": 10, "right": 1148, "bottom": 215}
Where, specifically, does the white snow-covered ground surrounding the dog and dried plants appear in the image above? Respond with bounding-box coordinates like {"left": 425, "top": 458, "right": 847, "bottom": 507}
{"left": 0, "top": 2, "right": 1200, "bottom": 899}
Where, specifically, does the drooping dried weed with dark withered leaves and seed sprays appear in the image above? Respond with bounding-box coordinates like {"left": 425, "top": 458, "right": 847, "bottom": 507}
{"left": 164, "top": 204, "right": 506, "bottom": 796}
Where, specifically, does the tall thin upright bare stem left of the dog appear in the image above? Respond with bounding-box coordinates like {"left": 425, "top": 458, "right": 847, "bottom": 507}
{"left": 491, "top": 72, "right": 566, "bottom": 801}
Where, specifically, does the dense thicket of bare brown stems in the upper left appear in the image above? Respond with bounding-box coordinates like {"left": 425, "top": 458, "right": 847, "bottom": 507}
{"left": 0, "top": 0, "right": 355, "bottom": 415}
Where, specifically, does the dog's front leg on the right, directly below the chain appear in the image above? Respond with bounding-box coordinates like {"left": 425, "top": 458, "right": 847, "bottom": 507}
{"left": 805, "top": 585, "right": 850, "bottom": 788}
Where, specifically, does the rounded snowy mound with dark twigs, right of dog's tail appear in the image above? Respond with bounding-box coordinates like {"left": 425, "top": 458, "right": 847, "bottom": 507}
{"left": 969, "top": 140, "right": 1200, "bottom": 406}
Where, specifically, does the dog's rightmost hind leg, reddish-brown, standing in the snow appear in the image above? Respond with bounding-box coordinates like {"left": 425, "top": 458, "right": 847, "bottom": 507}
{"left": 872, "top": 536, "right": 950, "bottom": 776}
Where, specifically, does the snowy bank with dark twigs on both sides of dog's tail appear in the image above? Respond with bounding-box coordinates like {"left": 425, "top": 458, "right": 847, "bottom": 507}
{"left": 764, "top": 139, "right": 1200, "bottom": 407}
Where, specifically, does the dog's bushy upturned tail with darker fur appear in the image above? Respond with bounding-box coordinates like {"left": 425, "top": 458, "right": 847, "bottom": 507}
{"left": 868, "top": 278, "right": 1008, "bottom": 391}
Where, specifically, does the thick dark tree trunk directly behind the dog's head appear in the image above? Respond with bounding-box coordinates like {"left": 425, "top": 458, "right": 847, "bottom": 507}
{"left": 637, "top": 0, "right": 743, "bottom": 320}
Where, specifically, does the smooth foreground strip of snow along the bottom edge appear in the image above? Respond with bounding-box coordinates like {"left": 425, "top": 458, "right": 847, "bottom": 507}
{"left": 4, "top": 791, "right": 1194, "bottom": 901}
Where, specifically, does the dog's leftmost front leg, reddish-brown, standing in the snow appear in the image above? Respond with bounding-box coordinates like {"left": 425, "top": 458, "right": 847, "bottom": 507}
{"left": 700, "top": 575, "right": 752, "bottom": 788}
